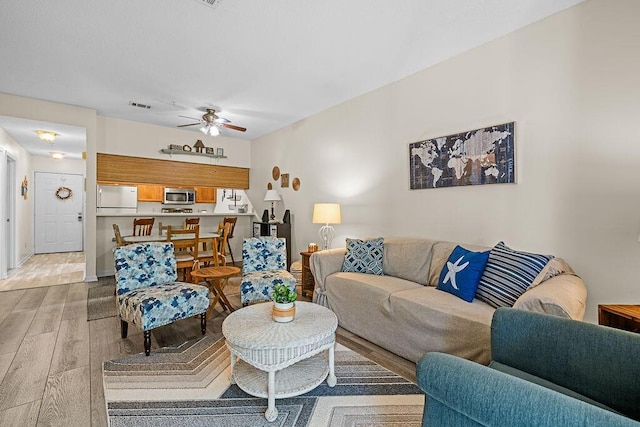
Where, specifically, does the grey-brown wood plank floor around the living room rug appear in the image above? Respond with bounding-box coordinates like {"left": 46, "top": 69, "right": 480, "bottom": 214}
{"left": 0, "top": 278, "right": 415, "bottom": 427}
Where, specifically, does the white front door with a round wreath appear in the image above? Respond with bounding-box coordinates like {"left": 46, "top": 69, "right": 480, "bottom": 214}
{"left": 34, "top": 172, "right": 84, "bottom": 254}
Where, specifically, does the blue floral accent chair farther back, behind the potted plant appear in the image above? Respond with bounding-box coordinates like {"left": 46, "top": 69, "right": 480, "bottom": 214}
{"left": 240, "top": 237, "right": 296, "bottom": 306}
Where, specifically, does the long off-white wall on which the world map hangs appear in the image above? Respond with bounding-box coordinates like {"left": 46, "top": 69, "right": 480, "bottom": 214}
{"left": 249, "top": 0, "right": 640, "bottom": 321}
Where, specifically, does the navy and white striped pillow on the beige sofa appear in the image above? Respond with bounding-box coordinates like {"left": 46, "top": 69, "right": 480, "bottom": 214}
{"left": 476, "top": 242, "right": 553, "bottom": 308}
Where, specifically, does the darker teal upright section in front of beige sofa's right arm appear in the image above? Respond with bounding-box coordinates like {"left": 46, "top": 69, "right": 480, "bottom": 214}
{"left": 491, "top": 308, "right": 640, "bottom": 420}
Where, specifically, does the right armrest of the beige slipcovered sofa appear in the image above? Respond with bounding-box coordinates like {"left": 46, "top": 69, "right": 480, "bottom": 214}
{"left": 513, "top": 274, "right": 587, "bottom": 320}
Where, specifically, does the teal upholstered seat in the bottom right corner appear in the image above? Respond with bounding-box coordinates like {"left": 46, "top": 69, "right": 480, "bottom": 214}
{"left": 416, "top": 308, "right": 640, "bottom": 427}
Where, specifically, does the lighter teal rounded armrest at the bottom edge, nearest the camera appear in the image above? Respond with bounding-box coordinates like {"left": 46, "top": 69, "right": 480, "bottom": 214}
{"left": 416, "top": 353, "right": 640, "bottom": 427}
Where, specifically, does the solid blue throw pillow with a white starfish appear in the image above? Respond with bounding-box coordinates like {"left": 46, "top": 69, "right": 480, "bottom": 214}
{"left": 437, "top": 246, "right": 489, "bottom": 302}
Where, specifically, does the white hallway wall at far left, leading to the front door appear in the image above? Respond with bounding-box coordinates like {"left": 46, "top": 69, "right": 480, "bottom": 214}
{"left": 0, "top": 128, "right": 34, "bottom": 265}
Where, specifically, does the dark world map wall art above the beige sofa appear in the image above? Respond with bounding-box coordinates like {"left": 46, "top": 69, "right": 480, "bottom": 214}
{"left": 409, "top": 122, "right": 516, "bottom": 190}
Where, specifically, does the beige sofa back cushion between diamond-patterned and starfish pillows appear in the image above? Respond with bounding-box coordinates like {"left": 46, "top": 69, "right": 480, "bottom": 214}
{"left": 382, "top": 237, "right": 437, "bottom": 285}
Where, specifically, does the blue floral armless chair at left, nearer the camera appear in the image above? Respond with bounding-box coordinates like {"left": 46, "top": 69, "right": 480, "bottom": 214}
{"left": 113, "top": 242, "right": 209, "bottom": 356}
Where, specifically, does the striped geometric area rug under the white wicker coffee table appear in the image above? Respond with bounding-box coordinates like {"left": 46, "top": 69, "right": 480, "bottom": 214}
{"left": 103, "top": 334, "right": 424, "bottom": 427}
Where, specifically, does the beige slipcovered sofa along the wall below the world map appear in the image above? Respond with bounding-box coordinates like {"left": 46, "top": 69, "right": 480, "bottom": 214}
{"left": 310, "top": 238, "right": 587, "bottom": 364}
